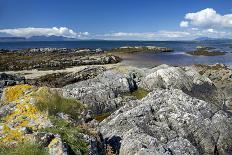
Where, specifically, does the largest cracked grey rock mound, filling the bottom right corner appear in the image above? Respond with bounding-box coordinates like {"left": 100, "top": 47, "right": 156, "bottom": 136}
{"left": 100, "top": 89, "right": 232, "bottom": 155}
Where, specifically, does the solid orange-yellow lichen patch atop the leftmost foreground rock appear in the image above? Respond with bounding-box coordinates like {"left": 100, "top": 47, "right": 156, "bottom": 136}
{"left": 4, "top": 85, "right": 33, "bottom": 103}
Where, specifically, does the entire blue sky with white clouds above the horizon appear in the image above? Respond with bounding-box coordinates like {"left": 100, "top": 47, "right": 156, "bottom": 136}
{"left": 0, "top": 0, "right": 232, "bottom": 40}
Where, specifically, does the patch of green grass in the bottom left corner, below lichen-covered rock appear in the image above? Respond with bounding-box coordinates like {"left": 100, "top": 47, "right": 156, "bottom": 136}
{"left": 0, "top": 143, "right": 48, "bottom": 155}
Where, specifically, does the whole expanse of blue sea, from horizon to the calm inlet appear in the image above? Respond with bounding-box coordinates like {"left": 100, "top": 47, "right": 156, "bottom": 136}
{"left": 0, "top": 41, "right": 232, "bottom": 67}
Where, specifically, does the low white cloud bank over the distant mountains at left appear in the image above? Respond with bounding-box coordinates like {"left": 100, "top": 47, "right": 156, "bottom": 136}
{"left": 0, "top": 27, "right": 89, "bottom": 38}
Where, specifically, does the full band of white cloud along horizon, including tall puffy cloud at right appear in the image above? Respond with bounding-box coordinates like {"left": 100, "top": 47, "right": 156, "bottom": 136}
{"left": 0, "top": 8, "right": 232, "bottom": 40}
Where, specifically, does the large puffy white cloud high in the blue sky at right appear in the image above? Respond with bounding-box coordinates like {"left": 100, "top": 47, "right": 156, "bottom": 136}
{"left": 180, "top": 8, "right": 232, "bottom": 29}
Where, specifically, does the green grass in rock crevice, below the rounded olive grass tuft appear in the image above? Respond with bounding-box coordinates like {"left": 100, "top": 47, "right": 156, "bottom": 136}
{"left": 41, "top": 116, "right": 88, "bottom": 155}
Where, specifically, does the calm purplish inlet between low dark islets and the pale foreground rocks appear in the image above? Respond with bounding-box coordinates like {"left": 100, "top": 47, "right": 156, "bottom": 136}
{"left": 122, "top": 53, "right": 232, "bottom": 67}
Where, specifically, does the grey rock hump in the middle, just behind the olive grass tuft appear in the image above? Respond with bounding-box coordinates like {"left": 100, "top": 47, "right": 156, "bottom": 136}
{"left": 63, "top": 70, "right": 136, "bottom": 114}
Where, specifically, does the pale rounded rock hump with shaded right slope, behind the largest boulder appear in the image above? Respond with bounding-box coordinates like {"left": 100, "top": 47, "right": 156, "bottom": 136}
{"left": 139, "top": 65, "right": 221, "bottom": 106}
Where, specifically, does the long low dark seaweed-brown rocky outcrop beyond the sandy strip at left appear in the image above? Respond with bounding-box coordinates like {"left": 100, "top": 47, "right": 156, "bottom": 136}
{"left": 0, "top": 48, "right": 121, "bottom": 71}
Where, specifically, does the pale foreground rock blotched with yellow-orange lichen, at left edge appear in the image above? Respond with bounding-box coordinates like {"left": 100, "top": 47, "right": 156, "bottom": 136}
{"left": 0, "top": 85, "right": 52, "bottom": 145}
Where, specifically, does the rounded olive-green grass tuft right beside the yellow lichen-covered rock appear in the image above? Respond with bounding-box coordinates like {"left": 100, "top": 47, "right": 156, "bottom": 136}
{"left": 35, "top": 92, "right": 85, "bottom": 119}
